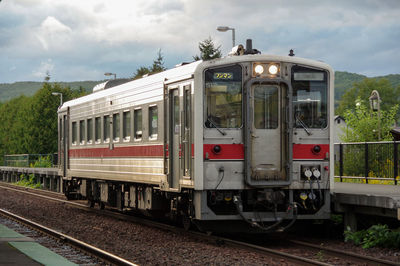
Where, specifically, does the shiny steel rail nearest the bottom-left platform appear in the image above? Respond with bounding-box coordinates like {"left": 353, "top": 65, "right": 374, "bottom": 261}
{"left": 0, "top": 209, "right": 137, "bottom": 266}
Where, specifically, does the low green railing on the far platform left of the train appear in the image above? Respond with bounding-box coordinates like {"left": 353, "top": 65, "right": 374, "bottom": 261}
{"left": 3, "top": 153, "right": 57, "bottom": 168}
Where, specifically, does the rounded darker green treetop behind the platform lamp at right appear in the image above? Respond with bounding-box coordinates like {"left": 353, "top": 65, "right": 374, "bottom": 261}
{"left": 336, "top": 78, "right": 400, "bottom": 117}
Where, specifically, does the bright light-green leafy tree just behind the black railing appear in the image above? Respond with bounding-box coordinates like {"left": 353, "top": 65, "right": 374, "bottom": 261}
{"left": 340, "top": 98, "right": 398, "bottom": 142}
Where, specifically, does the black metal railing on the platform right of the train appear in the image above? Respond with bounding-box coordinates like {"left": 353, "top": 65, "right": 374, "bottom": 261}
{"left": 334, "top": 141, "right": 400, "bottom": 185}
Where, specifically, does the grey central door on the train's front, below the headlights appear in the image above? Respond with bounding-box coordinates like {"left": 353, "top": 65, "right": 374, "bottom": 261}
{"left": 246, "top": 83, "right": 287, "bottom": 185}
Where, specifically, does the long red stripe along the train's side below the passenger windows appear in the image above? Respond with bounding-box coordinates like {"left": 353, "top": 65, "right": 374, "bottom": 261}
{"left": 69, "top": 145, "right": 164, "bottom": 158}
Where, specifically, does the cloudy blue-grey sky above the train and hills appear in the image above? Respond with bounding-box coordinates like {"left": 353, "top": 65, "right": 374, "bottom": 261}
{"left": 0, "top": 0, "right": 400, "bottom": 83}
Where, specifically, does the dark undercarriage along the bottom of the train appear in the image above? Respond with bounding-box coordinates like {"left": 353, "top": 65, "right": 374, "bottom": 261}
{"left": 64, "top": 179, "right": 330, "bottom": 233}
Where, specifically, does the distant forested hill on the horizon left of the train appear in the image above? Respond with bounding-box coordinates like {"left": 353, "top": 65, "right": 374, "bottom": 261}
{"left": 0, "top": 81, "right": 103, "bottom": 102}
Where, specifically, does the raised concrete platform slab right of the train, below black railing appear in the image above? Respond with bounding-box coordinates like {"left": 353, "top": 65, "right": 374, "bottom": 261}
{"left": 332, "top": 182, "right": 400, "bottom": 230}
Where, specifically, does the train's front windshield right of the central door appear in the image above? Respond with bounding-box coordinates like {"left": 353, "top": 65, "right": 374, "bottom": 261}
{"left": 292, "top": 66, "right": 328, "bottom": 128}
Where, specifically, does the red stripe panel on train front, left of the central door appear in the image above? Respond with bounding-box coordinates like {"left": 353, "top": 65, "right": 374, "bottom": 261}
{"left": 203, "top": 144, "right": 244, "bottom": 160}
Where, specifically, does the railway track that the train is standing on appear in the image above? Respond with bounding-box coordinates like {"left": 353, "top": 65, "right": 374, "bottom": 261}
{"left": 0, "top": 184, "right": 399, "bottom": 265}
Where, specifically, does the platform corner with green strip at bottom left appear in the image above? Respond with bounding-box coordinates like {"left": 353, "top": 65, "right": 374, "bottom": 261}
{"left": 0, "top": 224, "right": 76, "bottom": 266}
